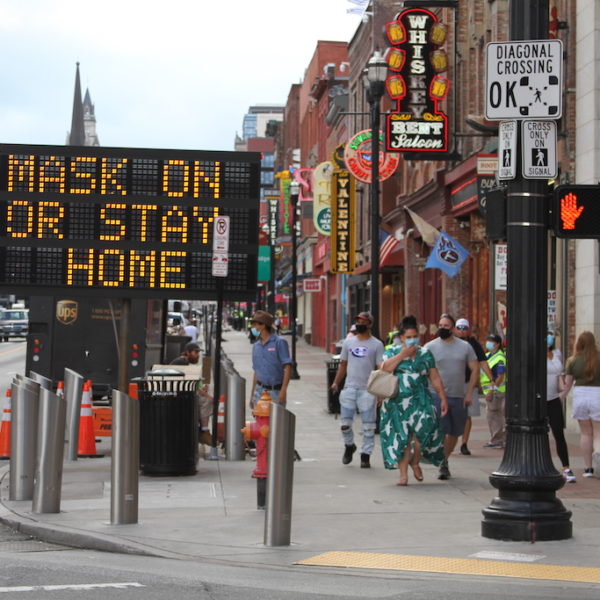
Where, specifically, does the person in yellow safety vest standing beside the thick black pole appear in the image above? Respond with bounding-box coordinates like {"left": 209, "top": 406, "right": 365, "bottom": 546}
{"left": 479, "top": 333, "right": 506, "bottom": 448}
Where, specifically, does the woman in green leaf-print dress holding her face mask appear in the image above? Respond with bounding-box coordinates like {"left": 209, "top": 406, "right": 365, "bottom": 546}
{"left": 379, "top": 317, "right": 448, "bottom": 486}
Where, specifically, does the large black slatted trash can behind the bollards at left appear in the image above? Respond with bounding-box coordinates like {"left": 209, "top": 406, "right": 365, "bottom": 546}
{"left": 138, "top": 373, "right": 198, "bottom": 475}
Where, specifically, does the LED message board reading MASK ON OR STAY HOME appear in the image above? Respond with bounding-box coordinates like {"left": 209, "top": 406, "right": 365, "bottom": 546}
{"left": 0, "top": 145, "right": 260, "bottom": 300}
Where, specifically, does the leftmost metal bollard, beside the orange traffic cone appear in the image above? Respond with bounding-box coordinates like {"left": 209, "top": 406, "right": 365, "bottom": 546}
{"left": 8, "top": 379, "right": 40, "bottom": 500}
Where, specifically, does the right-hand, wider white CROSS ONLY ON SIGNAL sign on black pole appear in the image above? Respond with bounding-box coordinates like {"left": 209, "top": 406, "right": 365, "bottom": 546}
{"left": 521, "top": 121, "right": 558, "bottom": 179}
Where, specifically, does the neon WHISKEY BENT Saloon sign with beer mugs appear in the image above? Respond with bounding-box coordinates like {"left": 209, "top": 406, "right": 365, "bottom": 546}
{"left": 385, "top": 8, "right": 450, "bottom": 152}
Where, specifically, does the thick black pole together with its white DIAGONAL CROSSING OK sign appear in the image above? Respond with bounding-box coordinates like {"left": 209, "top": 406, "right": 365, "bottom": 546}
{"left": 481, "top": 0, "right": 578, "bottom": 542}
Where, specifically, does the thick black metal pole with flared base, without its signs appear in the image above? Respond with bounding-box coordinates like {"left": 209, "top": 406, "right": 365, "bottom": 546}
{"left": 481, "top": 0, "right": 572, "bottom": 542}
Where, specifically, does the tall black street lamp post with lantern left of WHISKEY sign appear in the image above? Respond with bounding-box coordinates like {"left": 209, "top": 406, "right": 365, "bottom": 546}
{"left": 363, "top": 50, "right": 387, "bottom": 337}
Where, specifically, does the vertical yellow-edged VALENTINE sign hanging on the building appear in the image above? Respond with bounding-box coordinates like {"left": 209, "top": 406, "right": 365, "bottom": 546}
{"left": 331, "top": 169, "right": 355, "bottom": 273}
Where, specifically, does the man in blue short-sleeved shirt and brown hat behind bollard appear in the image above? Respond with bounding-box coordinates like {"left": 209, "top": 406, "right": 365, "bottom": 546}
{"left": 250, "top": 310, "right": 292, "bottom": 408}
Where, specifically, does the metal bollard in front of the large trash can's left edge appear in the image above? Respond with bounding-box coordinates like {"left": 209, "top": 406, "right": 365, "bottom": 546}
{"left": 110, "top": 390, "right": 140, "bottom": 525}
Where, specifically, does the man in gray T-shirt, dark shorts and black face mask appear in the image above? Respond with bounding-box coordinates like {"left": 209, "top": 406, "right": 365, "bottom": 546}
{"left": 425, "top": 314, "right": 479, "bottom": 479}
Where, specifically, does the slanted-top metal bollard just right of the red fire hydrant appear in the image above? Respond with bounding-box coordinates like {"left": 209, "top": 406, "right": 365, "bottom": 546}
{"left": 264, "top": 403, "right": 296, "bottom": 546}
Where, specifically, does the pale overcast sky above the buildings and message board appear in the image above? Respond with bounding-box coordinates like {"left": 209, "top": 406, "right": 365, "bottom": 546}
{"left": 0, "top": 0, "right": 360, "bottom": 150}
